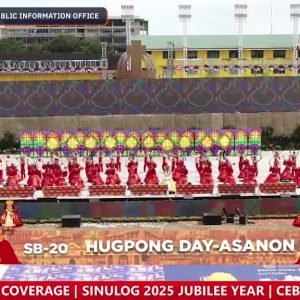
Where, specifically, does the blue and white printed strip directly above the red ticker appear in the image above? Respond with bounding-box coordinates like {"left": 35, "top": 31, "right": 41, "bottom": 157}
{"left": 0, "top": 265, "right": 300, "bottom": 281}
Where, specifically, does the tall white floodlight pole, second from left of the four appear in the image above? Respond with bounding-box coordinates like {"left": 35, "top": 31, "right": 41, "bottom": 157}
{"left": 178, "top": 4, "right": 192, "bottom": 78}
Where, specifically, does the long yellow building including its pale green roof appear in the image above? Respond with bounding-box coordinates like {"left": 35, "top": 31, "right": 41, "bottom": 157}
{"left": 134, "top": 35, "right": 300, "bottom": 78}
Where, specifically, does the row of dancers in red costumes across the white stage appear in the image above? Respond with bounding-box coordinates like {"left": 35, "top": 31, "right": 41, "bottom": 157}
{"left": 0, "top": 151, "right": 300, "bottom": 189}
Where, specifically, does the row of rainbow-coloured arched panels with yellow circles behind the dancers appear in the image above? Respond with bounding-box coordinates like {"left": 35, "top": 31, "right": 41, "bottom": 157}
{"left": 20, "top": 129, "right": 261, "bottom": 157}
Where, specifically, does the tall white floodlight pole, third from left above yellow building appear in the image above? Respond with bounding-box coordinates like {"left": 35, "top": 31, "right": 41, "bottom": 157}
{"left": 234, "top": 4, "right": 247, "bottom": 76}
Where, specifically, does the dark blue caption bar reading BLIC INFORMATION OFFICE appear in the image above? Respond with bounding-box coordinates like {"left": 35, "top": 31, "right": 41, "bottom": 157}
{"left": 0, "top": 7, "right": 108, "bottom": 26}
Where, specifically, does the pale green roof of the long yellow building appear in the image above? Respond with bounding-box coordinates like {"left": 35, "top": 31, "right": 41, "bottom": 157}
{"left": 133, "top": 34, "right": 293, "bottom": 50}
